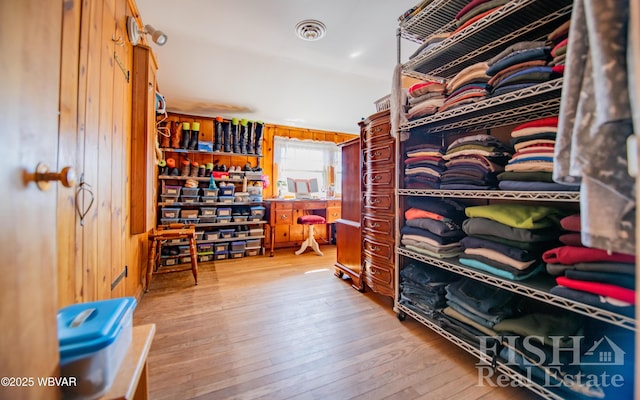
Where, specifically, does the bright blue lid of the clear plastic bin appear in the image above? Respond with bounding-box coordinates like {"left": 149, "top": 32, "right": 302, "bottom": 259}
{"left": 57, "top": 297, "right": 136, "bottom": 362}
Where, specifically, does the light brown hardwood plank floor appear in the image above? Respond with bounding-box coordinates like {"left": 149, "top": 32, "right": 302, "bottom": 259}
{"left": 134, "top": 245, "right": 534, "bottom": 400}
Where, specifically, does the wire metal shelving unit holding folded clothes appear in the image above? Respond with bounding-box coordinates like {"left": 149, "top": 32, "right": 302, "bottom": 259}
{"left": 394, "top": 0, "right": 636, "bottom": 399}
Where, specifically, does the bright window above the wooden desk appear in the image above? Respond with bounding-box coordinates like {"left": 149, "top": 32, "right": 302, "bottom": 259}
{"left": 273, "top": 136, "right": 342, "bottom": 193}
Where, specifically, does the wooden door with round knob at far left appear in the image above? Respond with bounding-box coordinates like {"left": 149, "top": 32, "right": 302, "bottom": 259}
{"left": 0, "top": 0, "right": 63, "bottom": 399}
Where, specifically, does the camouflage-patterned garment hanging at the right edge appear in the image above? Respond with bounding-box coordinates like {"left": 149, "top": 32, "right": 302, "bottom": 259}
{"left": 553, "top": 0, "right": 635, "bottom": 254}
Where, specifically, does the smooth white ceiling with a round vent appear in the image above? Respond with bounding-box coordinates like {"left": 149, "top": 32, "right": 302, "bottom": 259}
{"left": 136, "top": 0, "right": 418, "bottom": 133}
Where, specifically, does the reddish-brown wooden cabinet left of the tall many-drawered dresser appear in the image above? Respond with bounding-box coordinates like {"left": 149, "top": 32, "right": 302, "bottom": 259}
{"left": 327, "top": 138, "right": 364, "bottom": 291}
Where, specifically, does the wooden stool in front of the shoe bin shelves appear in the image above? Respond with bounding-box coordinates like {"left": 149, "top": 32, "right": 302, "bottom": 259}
{"left": 145, "top": 224, "right": 198, "bottom": 292}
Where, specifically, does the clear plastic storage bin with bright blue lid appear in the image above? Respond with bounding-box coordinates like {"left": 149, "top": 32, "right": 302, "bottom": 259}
{"left": 57, "top": 297, "right": 136, "bottom": 399}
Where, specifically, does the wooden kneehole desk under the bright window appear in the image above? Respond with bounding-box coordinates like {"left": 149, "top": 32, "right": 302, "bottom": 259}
{"left": 265, "top": 199, "right": 341, "bottom": 257}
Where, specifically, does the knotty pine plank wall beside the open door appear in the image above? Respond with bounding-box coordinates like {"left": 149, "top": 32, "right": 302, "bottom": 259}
{"left": 57, "top": 0, "right": 153, "bottom": 307}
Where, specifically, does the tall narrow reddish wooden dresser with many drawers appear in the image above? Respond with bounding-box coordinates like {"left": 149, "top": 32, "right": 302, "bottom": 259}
{"left": 361, "top": 110, "right": 396, "bottom": 297}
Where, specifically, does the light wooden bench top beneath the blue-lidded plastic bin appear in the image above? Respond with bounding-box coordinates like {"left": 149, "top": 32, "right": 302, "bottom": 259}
{"left": 101, "top": 324, "right": 156, "bottom": 400}
